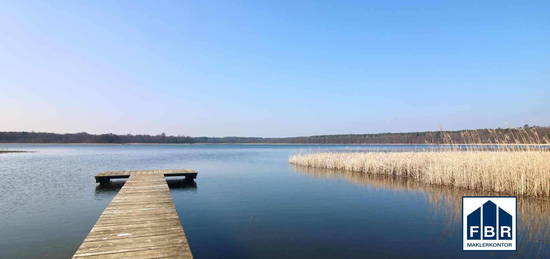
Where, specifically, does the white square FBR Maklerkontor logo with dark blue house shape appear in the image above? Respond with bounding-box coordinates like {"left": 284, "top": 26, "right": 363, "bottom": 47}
{"left": 462, "top": 196, "right": 517, "bottom": 250}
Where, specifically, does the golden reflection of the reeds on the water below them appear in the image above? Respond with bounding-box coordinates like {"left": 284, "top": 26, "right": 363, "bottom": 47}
{"left": 291, "top": 165, "right": 550, "bottom": 250}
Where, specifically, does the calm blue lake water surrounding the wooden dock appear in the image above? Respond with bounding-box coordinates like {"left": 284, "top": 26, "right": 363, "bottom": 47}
{"left": 0, "top": 145, "right": 550, "bottom": 258}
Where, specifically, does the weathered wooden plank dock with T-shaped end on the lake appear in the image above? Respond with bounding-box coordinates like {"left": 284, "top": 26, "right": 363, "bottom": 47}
{"left": 73, "top": 170, "right": 197, "bottom": 259}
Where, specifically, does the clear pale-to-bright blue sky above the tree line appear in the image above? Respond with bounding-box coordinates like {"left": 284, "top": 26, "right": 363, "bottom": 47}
{"left": 0, "top": 0, "right": 550, "bottom": 136}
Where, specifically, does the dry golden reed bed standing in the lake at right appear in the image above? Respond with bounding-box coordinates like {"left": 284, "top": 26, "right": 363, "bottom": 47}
{"left": 289, "top": 130, "right": 550, "bottom": 197}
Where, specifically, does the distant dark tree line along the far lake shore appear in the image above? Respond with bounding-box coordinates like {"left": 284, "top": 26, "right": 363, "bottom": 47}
{"left": 0, "top": 125, "right": 550, "bottom": 144}
